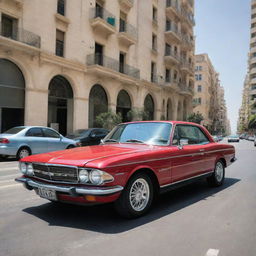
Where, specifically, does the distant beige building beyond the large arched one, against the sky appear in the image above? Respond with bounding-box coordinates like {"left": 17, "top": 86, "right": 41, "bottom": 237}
{"left": 193, "top": 54, "right": 230, "bottom": 134}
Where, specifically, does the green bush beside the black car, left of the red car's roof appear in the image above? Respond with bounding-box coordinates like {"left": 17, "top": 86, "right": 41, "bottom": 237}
{"left": 96, "top": 111, "right": 122, "bottom": 130}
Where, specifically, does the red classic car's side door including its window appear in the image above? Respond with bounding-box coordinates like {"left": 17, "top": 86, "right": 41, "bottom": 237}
{"left": 171, "top": 124, "right": 209, "bottom": 182}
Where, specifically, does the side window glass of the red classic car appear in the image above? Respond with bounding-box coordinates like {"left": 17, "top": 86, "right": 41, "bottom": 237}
{"left": 172, "top": 125, "right": 209, "bottom": 145}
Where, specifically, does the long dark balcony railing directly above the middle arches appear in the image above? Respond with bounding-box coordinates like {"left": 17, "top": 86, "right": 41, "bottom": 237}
{"left": 86, "top": 53, "right": 140, "bottom": 79}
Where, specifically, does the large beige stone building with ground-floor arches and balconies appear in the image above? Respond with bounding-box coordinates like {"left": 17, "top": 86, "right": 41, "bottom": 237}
{"left": 0, "top": 0, "right": 194, "bottom": 134}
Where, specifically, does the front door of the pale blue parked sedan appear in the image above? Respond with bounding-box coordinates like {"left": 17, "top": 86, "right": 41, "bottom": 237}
{"left": 43, "top": 128, "right": 63, "bottom": 152}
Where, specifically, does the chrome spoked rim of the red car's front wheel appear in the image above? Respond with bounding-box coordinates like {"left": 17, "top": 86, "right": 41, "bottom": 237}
{"left": 129, "top": 178, "right": 150, "bottom": 212}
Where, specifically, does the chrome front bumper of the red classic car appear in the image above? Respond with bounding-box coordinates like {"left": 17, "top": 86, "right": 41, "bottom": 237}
{"left": 15, "top": 178, "right": 123, "bottom": 196}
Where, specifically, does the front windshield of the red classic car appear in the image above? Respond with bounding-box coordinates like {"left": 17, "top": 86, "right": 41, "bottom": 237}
{"left": 103, "top": 122, "right": 172, "bottom": 146}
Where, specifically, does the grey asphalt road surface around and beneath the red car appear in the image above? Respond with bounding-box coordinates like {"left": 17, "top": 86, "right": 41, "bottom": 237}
{"left": 0, "top": 141, "right": 256, "bottom": 256}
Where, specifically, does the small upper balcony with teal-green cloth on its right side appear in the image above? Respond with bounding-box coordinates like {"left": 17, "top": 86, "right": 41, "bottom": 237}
{"left": 90, "top": 8, "right": 116, "bottom": 37}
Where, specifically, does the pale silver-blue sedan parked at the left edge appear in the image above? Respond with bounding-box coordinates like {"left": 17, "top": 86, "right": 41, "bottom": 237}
{"left": 0, "top": 126, "right": 77, "bottom": 159}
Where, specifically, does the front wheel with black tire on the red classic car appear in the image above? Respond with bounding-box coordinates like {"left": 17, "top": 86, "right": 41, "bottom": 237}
{"left": 115, "top": 173, "right": 154, "bottom": 219}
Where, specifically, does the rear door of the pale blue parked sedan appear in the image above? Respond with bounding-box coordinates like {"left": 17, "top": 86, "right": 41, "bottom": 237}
{"left": 25, "top": 127, "right": 48, "bottom": 154}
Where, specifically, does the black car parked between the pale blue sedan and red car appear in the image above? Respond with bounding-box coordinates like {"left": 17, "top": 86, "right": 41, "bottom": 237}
{"left": 67, "top": 128, "right": 109, "bottom": 146}
